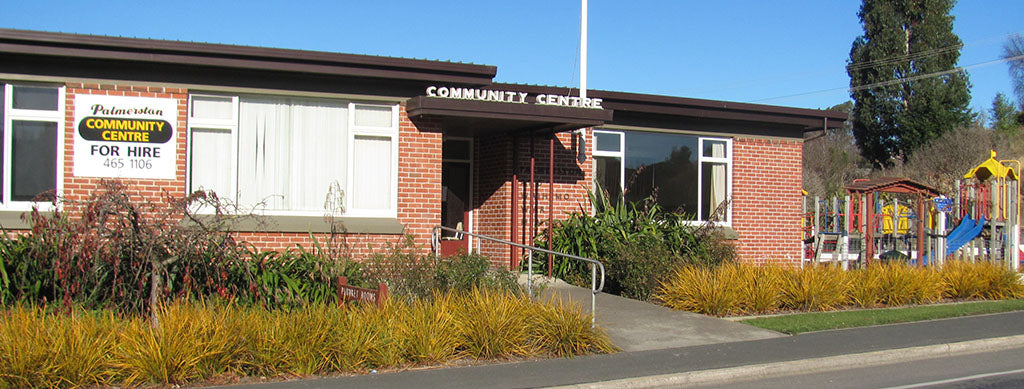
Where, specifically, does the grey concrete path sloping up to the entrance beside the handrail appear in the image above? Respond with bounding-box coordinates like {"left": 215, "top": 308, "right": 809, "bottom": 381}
{"left": 520, "top": 275, "right": 785, "bottom": 351}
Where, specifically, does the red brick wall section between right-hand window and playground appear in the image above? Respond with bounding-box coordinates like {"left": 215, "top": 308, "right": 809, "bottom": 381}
{"left": 732, "top": 137, "right": 803, "bottom": 265}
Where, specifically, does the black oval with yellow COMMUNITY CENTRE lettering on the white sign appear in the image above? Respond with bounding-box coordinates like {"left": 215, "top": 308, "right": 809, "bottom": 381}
{"left": 78, "top": 117, "right": 174, "bottom": 143}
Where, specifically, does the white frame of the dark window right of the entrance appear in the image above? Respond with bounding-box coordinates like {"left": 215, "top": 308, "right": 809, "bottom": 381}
{"left": 592, "top": 130, "right": 733, "bottom": 227}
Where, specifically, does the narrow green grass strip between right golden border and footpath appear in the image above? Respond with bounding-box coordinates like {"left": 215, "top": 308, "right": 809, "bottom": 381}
{"left": 740, "top": 300, "right": 1024, "bottom": 334}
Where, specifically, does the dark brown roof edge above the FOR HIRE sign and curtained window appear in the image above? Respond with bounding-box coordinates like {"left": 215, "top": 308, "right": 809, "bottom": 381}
{"left": 0, "top": 29, "right": 498, "bottom": 85}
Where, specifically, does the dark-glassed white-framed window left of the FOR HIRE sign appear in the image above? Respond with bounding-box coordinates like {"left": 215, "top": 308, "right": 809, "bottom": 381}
{"left": 0, "top": 84, "right": 65, "bottom": 210}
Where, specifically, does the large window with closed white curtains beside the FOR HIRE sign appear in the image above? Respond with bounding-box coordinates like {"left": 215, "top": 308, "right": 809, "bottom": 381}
{"left": 188, "top": 95, "right": 398, "bottom": 217}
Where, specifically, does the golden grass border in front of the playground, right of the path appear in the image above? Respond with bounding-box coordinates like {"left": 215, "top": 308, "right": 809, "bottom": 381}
{"left": 655, "top": 261, "right": 1024, "bottom": 316}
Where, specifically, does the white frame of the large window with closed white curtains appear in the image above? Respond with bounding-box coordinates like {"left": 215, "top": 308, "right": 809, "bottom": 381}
{"left": 185, "top": 93, "right": 399, "bottom": 219}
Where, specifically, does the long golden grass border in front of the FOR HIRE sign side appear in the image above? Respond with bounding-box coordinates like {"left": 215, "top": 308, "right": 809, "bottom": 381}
{"left": 0, "top": 290, "right": 614, "bottom": 387}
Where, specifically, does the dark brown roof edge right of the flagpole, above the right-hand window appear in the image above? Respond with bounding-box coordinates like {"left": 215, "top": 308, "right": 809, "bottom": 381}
{"left": 487, "top": 83, "right": 849, "bottom": 131}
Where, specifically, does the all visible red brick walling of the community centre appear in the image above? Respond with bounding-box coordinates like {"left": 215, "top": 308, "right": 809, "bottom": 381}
{"left": 51, "top": 83, "right": 802, "bottom": 266}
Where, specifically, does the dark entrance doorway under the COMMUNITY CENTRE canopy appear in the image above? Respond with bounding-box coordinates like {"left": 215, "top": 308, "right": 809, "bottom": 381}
{"left": 440, "top": 137, "right": 473, "bottom": 255}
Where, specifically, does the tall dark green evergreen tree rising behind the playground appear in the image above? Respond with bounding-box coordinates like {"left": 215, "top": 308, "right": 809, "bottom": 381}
{"left": 847, "top": 0, "right": 972, "bottom": 167}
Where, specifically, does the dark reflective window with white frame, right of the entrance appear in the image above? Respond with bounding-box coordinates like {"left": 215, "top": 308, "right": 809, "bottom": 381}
{"left": 594, "top": 130, "right": 732, "bottom": 222}
